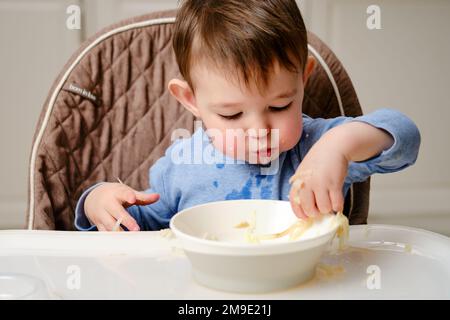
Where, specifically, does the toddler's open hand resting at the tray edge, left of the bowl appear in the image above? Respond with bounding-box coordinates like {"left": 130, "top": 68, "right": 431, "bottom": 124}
{"left": 84, "top": 183, "right": 159, "bottom": 231}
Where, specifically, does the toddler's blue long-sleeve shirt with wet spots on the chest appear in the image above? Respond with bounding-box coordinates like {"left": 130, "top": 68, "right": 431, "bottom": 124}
{"left": 75, "top": 109, "right": 420, "bottom": 230}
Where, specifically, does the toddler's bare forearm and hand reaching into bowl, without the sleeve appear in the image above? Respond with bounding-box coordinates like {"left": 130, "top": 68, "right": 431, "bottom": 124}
{"left": 289, "top": 121, "right": 394, "bottom": 218}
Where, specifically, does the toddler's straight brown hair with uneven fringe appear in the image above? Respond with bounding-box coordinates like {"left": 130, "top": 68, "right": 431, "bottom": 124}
{"left": 173, "top": 0, "right": 308, "bottom": 90}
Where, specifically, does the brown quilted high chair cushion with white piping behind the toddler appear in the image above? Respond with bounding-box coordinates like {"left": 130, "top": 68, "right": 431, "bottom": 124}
{"left": 27, "top": 11, "right": 369, "bottom": 230}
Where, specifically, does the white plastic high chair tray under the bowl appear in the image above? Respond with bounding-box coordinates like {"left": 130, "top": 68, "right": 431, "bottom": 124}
{"left": 0, "top": 225, "right": 450, "bottom": 299}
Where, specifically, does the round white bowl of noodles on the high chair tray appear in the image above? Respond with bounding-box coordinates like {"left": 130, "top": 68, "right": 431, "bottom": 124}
{"left": 170, "top": 200, "right": 337, "bottom": 293}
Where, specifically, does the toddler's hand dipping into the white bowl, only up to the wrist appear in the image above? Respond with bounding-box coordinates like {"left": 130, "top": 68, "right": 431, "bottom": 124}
{"left": 289, "top": 141, "right": 348, "bottom": 219}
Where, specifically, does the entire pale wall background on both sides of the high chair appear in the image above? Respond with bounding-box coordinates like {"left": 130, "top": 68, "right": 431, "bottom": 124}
{"left": 0, "top": 0, "right": 450, "bottom": 235}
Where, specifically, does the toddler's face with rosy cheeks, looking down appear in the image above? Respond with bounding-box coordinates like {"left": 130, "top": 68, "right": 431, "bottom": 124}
{"left": 169, "top": 57, "right": 309, "bottom": 164}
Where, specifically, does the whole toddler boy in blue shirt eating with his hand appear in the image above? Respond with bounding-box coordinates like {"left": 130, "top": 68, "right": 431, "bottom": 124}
{"left": 75, "top": 0, "right": 420, "bottom": 231}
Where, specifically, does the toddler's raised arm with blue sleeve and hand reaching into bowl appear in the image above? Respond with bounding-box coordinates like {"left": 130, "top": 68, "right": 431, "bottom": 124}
{"left": 289, "top": 109, "right": 420, "bottom": 218}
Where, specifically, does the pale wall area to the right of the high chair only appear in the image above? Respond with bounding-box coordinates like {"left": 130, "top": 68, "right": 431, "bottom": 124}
{"left": 302, "top": 0, "right": 450, "bottom": 235}
